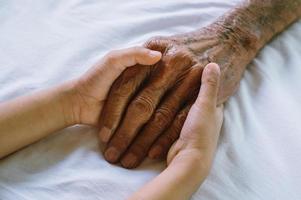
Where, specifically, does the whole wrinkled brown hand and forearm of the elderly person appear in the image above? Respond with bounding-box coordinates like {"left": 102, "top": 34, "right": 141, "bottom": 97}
{"left": 100, "top": 0, "right": 301, "bottom": 168}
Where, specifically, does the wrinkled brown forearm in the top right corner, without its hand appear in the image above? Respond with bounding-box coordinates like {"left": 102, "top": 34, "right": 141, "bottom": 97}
{"left": 214, "top": 0, "right": 301, "bottom": 53}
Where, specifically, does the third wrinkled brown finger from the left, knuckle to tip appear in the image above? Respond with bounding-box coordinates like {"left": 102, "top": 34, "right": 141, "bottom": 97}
{"left": 121, "top": 66, "right": 201, "bottom": 168}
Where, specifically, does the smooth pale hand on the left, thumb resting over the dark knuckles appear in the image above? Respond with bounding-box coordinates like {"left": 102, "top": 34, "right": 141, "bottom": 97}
{"left": 71, "top": 47, "right": 161, "bottom": 125}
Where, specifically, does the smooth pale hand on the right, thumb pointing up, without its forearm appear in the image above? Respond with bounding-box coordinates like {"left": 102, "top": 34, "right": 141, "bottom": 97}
{"left": 167, "top": 64, "right": 223, "bottom": 169}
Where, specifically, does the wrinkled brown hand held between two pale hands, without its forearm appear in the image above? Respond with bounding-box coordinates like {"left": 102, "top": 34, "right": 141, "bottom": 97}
{"left": 99, "top": 25, "right": 243, "bottom": 168}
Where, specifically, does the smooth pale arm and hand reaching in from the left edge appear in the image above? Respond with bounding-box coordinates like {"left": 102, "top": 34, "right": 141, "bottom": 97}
{"left": 0, "top": 47, "right": 161, "bottom": 158}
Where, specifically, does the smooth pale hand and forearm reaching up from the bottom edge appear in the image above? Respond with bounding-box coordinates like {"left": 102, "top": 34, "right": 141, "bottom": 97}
{"left": 127, "top": 64, "right": 223, "bottom": 200}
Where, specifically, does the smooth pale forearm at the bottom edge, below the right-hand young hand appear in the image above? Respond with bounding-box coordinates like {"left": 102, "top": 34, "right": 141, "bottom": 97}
{"left": 129, "top": 152, "right": 208, "bottom": 200}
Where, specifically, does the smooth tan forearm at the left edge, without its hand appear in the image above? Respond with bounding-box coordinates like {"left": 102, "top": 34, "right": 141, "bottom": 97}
{"left": 0, "top": 83, "right": 73, "bottom": 158}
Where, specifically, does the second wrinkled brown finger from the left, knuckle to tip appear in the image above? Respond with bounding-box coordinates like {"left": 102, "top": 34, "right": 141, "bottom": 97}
{"left": 105, "top": 51, "right": 191, "bottom": 162}
